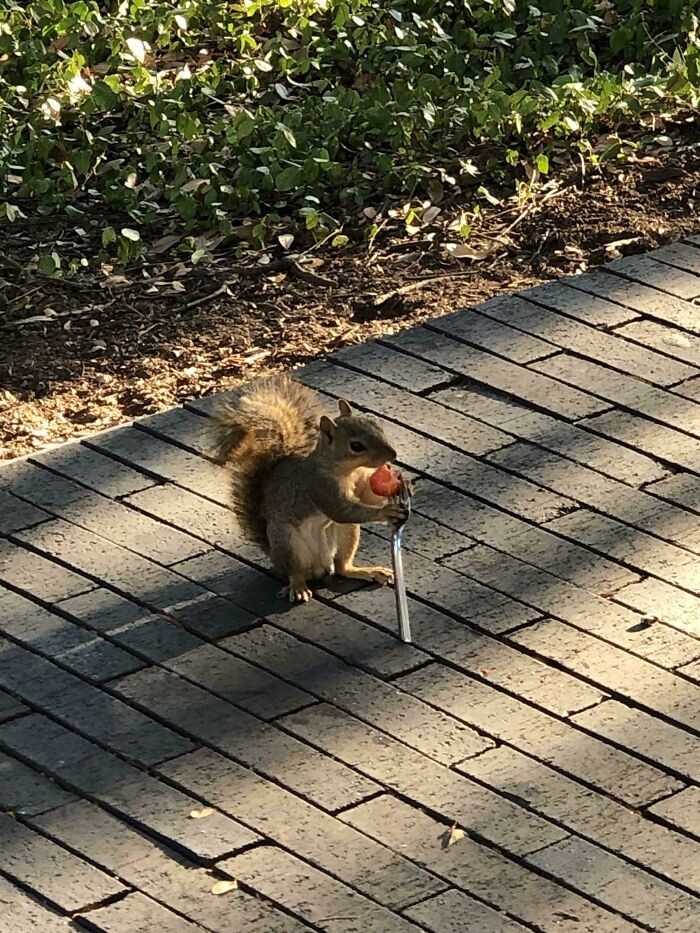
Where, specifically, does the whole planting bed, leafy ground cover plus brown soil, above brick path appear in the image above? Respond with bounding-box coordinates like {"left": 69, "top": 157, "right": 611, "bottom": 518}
{"left": 0, "top": 0, "right": 700, "bottom": 456}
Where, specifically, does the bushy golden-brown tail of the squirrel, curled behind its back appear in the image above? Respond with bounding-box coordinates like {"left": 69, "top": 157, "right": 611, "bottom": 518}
{"left": 214, "top": 376, "right": 323, "bottom": 550}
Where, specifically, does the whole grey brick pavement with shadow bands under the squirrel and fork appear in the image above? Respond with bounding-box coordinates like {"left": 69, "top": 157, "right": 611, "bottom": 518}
{"left": 0, "top": 237, "right": 700, "bottom": 933}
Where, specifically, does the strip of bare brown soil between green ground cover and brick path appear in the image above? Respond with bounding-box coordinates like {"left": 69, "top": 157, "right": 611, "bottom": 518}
{"left": 0, "top": 127, "right": 700, "bottom": 459}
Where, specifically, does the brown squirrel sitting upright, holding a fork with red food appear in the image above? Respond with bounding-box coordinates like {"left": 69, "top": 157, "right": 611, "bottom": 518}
{"left": 213, "top": 376, "right": 406, "bottom": 603}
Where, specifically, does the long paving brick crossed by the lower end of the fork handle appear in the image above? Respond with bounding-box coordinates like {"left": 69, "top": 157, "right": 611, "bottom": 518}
{"left": 340, "top": 591, "right": 604, "bottom": 716}
